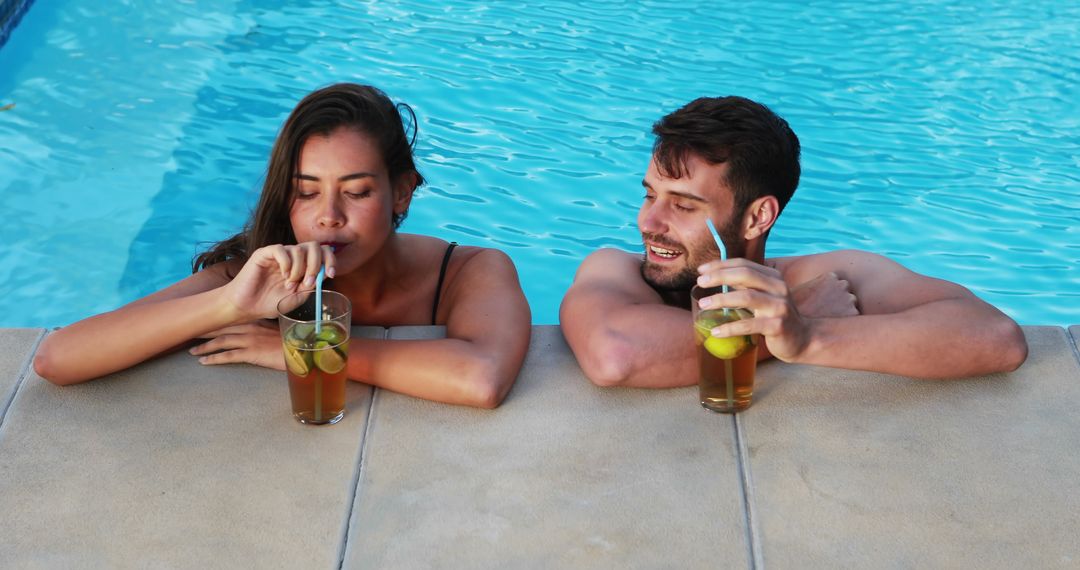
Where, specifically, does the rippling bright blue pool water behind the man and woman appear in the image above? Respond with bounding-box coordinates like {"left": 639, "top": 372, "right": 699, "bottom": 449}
{"left": 0, "top": 0, "right": 1080, "bottom": 327}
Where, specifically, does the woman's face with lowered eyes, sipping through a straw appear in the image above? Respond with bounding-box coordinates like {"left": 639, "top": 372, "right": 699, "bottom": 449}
{"left": 288, "top": 127, "right": 413, "bottom": 275}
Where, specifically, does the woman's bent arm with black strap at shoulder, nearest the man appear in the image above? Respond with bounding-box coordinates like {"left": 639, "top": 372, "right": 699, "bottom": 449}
{"left": 349, "top": 249, "right": 531, "bottom": 408}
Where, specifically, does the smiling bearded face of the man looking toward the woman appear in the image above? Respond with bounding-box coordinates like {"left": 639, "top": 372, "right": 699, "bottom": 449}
{"left": 637, "top": 154, "right": 745, "bottom": 291}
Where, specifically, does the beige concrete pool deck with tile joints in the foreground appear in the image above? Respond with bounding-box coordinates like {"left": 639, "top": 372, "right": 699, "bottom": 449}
{"left": 0, "top": 326, "right": 1080, "bottom": 569}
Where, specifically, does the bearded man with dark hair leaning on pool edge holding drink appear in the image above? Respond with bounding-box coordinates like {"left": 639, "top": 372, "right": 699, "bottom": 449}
{"left": 559, "top": 97, "right": 1027, "bottom": 388}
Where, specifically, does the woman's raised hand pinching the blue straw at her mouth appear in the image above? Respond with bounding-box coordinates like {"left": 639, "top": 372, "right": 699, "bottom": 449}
{"left": 225, "top": 242, "right": 335, "bottom": 322}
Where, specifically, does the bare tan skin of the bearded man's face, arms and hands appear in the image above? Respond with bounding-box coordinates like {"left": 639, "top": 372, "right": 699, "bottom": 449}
{"left": 559, "top": 155, "right": 1027, "bottom": 388}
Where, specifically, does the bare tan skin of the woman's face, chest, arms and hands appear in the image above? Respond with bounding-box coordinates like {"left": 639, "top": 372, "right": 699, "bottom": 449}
{"left": 35, "top": 128, "right": 531, "bottom": 408}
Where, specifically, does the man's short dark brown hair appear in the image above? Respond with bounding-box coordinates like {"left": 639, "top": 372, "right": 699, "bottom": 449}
{"left": 652, "top": 96, "right": 799, "bottom": 213}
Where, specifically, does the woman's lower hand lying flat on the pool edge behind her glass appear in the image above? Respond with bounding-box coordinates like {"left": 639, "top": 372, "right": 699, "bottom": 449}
{"left": 188, "top": 321, "right": 285, "bottom": 370}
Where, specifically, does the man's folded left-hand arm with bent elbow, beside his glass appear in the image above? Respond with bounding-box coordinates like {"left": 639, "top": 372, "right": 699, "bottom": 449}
{"left": 559, "top": 249, "right": 698, "bottom": 388}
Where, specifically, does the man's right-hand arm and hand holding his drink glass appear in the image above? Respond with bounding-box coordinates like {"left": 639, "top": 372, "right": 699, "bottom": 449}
{"left": 702, "top": 250, "right": 1027, "bottom": 378}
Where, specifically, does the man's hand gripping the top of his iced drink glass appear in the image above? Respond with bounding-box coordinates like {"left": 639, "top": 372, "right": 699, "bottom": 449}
{"left": 698, "top": 258, "right": 812, "bottom": 362}
